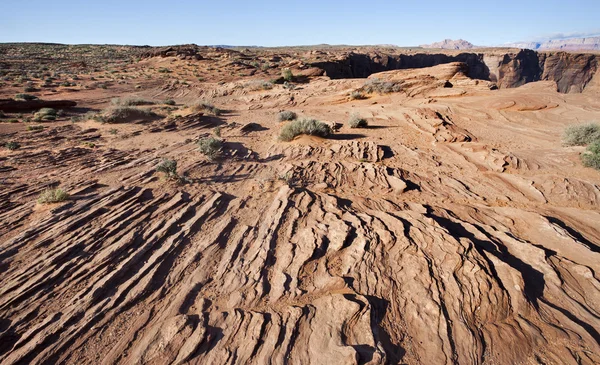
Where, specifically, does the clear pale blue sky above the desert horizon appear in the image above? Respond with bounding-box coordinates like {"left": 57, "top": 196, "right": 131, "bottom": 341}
{"left": 0, "top": 0, "right": 600, "bottom": 46}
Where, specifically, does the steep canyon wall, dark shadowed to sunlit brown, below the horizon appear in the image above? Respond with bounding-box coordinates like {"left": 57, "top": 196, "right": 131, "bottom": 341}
{"left": 312, "top": 50, "right": 598, "bottom": 93}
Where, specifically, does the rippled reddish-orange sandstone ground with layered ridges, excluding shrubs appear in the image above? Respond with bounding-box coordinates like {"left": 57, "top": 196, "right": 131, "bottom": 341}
{"left": 0, "top": 52, "right": 600, "bottom": 364}
